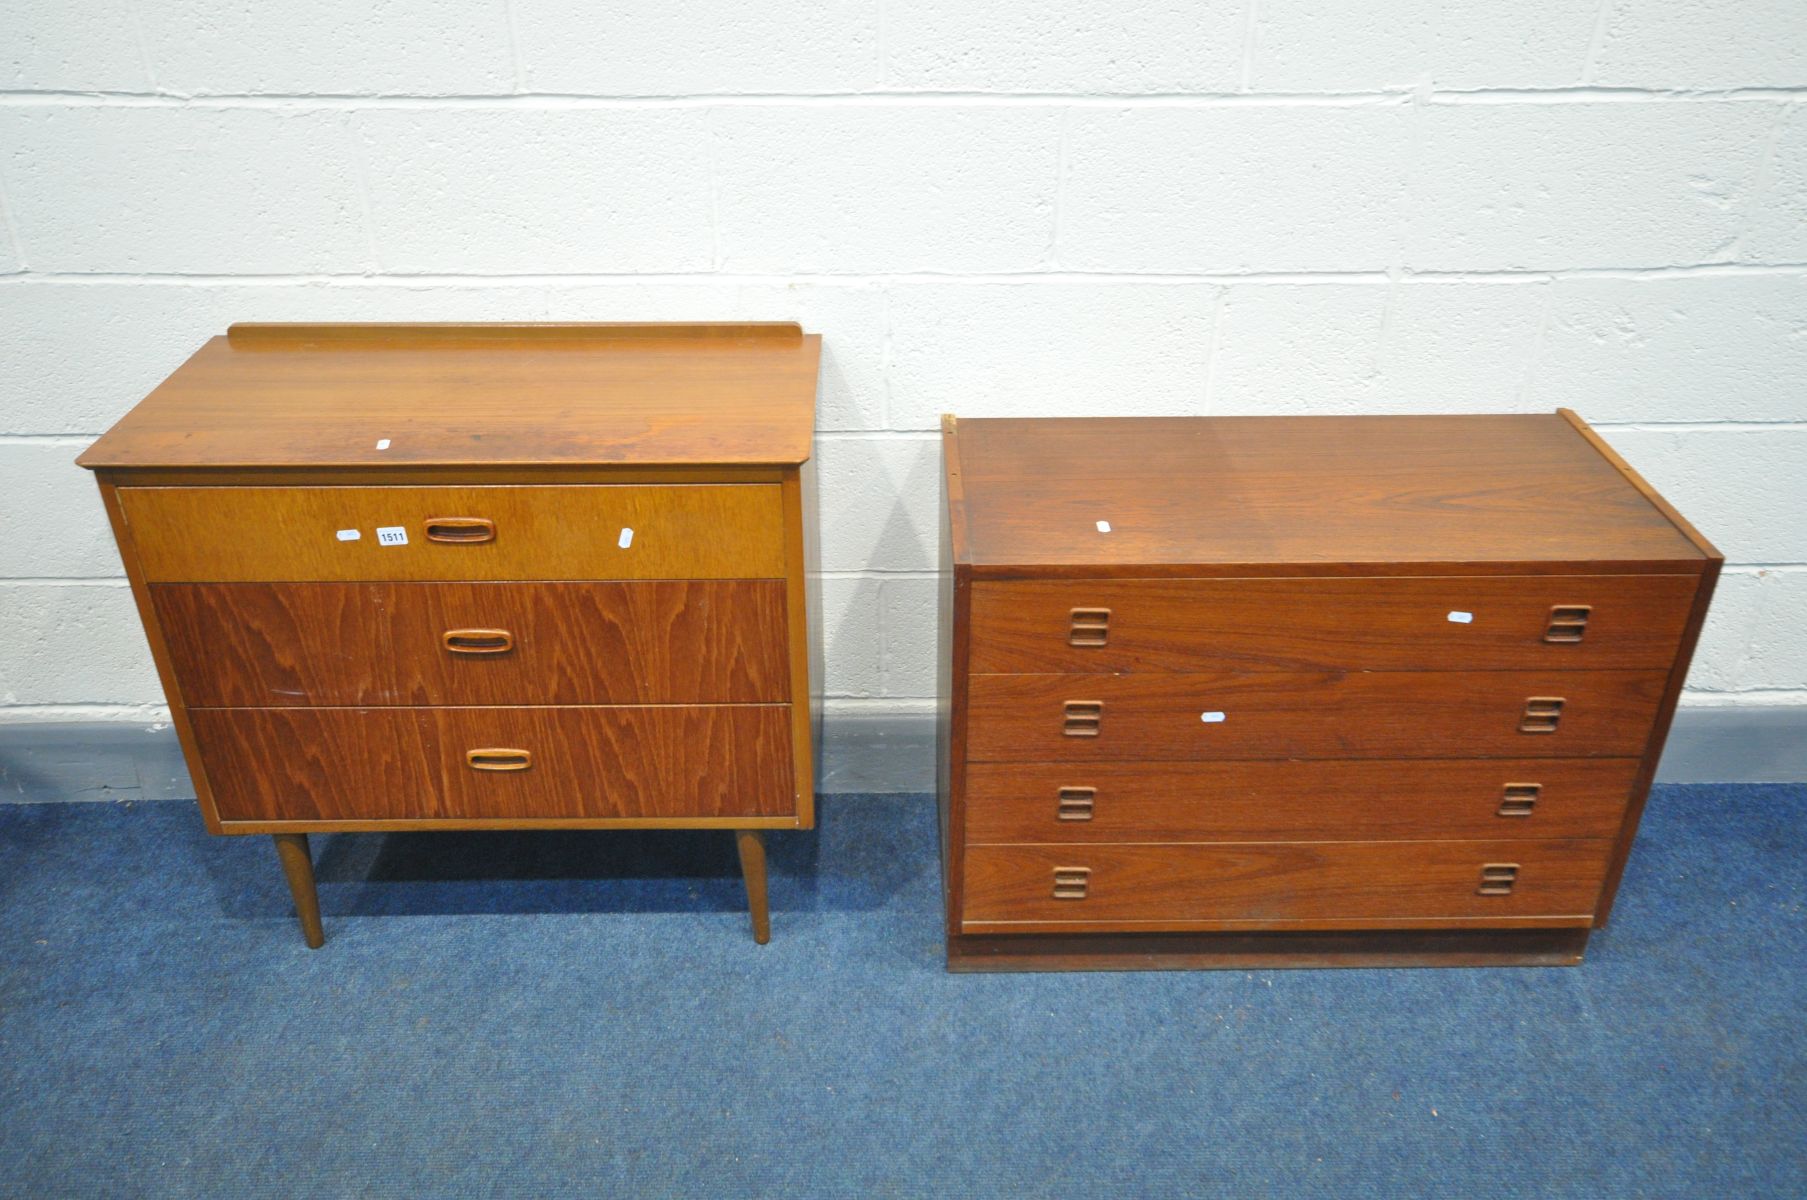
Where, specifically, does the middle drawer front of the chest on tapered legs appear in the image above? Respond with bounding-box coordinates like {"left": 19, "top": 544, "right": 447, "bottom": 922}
{"left": 150, "top": 580, "right": 790, "bottom": 708}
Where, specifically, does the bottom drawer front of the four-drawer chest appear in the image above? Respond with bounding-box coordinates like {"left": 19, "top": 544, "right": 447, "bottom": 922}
{"left": 963, "top": 840, "right": 1612, "bottom": 933}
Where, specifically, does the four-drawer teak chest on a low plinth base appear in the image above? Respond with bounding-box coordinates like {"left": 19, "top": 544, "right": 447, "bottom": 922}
{"left": 940, "top": 410, "right": 1720, "bottom": 970}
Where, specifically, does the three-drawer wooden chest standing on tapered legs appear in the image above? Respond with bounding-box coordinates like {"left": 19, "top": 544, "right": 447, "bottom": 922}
{"left": 80, "top": 325, "right": 820, "bottom": 945}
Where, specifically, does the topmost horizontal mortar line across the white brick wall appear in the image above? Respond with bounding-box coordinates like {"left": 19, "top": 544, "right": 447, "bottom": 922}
{"left": 0, "top": 87, "right": 1807, "bottom": 108}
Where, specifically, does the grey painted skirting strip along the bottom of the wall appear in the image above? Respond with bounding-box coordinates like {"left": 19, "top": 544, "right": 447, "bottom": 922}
{"left": 0, "top": 705, "right": 1807, "bottom": 804}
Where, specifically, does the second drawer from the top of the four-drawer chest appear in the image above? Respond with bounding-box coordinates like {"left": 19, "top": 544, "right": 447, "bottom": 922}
{"left": 967, "top": 670, "right": 1668, "bottom": 763}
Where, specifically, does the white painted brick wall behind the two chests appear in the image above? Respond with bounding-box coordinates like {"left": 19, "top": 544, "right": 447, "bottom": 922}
{"left": 0, "top": 0, "right": 1807, "bottom": 719}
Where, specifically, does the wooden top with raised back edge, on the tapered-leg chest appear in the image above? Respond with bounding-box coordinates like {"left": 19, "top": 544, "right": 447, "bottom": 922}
{"left": 78, "top": 323, "right": 822, "bottom": 470}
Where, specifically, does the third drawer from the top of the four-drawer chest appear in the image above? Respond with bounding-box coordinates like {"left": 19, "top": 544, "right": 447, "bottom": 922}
{"left": 967, "top": 759, "right": 1637, "bottom": 844}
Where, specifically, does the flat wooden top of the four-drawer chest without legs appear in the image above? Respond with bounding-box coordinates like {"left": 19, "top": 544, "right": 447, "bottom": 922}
{"left": 945, "top": 410, "right": 1715, "bottom": 577}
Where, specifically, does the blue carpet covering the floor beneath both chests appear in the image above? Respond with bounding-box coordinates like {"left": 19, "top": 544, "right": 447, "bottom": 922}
{"left": 0, "top": 786, "right": 1807, "bottom": 1200}
